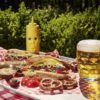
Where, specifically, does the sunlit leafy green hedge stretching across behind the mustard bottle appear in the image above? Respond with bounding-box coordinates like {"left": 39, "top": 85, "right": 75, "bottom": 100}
{"left": 0, "top": 3, "right": 100, "bottom": 57}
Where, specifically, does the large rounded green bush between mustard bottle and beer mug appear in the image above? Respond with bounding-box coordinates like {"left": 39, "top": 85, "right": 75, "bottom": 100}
{"left": 42, "top": 7, "right": 100, "bottom": 57}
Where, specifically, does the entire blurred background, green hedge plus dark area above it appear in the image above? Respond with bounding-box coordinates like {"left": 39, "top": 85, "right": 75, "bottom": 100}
{"left": 0, "top": 0, "right": 100, "bottom": 57}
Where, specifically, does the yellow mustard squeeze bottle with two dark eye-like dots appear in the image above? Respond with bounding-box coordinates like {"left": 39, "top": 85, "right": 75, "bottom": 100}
{"left": 26, "top": 17, "right": 40, "bottom": 53}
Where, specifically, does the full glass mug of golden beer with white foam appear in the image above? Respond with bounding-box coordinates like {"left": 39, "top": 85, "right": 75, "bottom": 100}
{"left": 76, "top": 40, "right": 100, "bottom": 100}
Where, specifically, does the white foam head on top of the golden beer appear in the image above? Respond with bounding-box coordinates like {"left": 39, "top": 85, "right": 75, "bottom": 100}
{"left": 77, "top": 40, "right": 100, "bottom": 52}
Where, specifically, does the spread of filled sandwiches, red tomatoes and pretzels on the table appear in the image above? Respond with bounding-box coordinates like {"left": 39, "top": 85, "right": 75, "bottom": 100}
{"left": 0, "top": 49, "right": 78, "bottom": 95}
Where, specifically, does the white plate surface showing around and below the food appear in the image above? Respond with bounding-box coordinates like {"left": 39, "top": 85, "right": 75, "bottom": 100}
{"left": 0, "top": 56, "right": 87, "bottom": 100}
